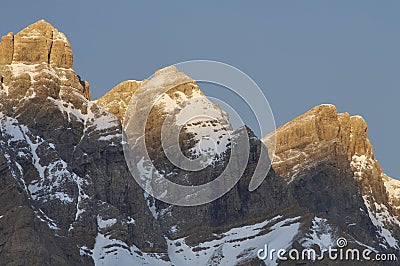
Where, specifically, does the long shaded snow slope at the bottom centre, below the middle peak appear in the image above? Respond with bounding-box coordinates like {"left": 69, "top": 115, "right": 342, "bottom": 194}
{"left": 168, "top": 216, "right": 300, "bottom": 265}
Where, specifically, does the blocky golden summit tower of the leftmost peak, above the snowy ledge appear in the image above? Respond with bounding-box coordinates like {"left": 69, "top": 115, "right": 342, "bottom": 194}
{"left": 0, "top": 19, "right": 73, "bottom": 68}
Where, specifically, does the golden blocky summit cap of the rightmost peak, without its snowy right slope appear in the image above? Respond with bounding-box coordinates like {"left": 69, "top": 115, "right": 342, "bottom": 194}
{"left": 263, "top": 104, "right": 374, "bottom": 181}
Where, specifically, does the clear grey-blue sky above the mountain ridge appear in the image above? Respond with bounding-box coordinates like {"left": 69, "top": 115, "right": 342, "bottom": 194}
{"left": 0, "top": 0, "right": 400, "bottom": 178}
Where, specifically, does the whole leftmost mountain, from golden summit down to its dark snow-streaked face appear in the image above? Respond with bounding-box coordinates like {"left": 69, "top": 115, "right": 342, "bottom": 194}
{"left": 0, "top": 21, "right": 166, "bottom": 265}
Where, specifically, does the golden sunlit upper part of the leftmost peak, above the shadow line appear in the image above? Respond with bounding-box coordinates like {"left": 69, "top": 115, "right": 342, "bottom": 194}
{"left": 0, "top": 20, "right": 91, "bottom": 103}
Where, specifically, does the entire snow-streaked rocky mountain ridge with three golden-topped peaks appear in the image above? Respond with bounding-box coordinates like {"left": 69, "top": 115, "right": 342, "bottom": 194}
{"left": 0, "top": 20, "right": 400, "bottom": 265}
